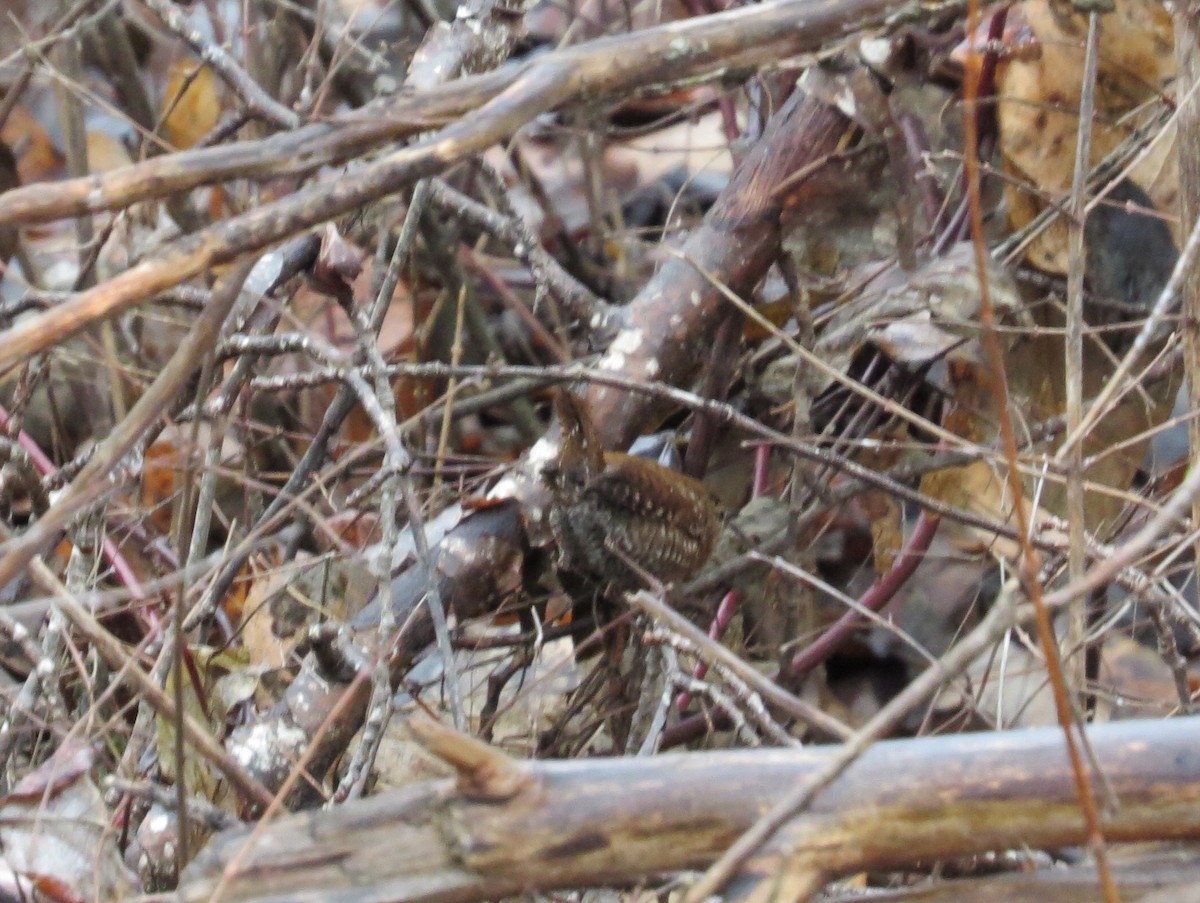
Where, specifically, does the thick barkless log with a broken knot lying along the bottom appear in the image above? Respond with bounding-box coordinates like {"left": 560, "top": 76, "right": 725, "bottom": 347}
{"left": 172, "top": 718, "right": 1200, "bottom": 903}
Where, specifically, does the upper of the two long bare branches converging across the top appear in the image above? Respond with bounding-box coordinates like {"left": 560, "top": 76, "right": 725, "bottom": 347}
{"left": 0, "top": 0, "right": 945, "bottom": 225}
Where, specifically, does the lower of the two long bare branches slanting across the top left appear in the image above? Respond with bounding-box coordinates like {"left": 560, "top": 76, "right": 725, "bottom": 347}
{"left": 0, "top": 0, "right": 964, "bottom": 372}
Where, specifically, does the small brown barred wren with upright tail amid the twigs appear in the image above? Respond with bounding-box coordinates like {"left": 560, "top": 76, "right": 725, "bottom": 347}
{"left": 545, "top": 389, "right": 720, "bottom": 590}
